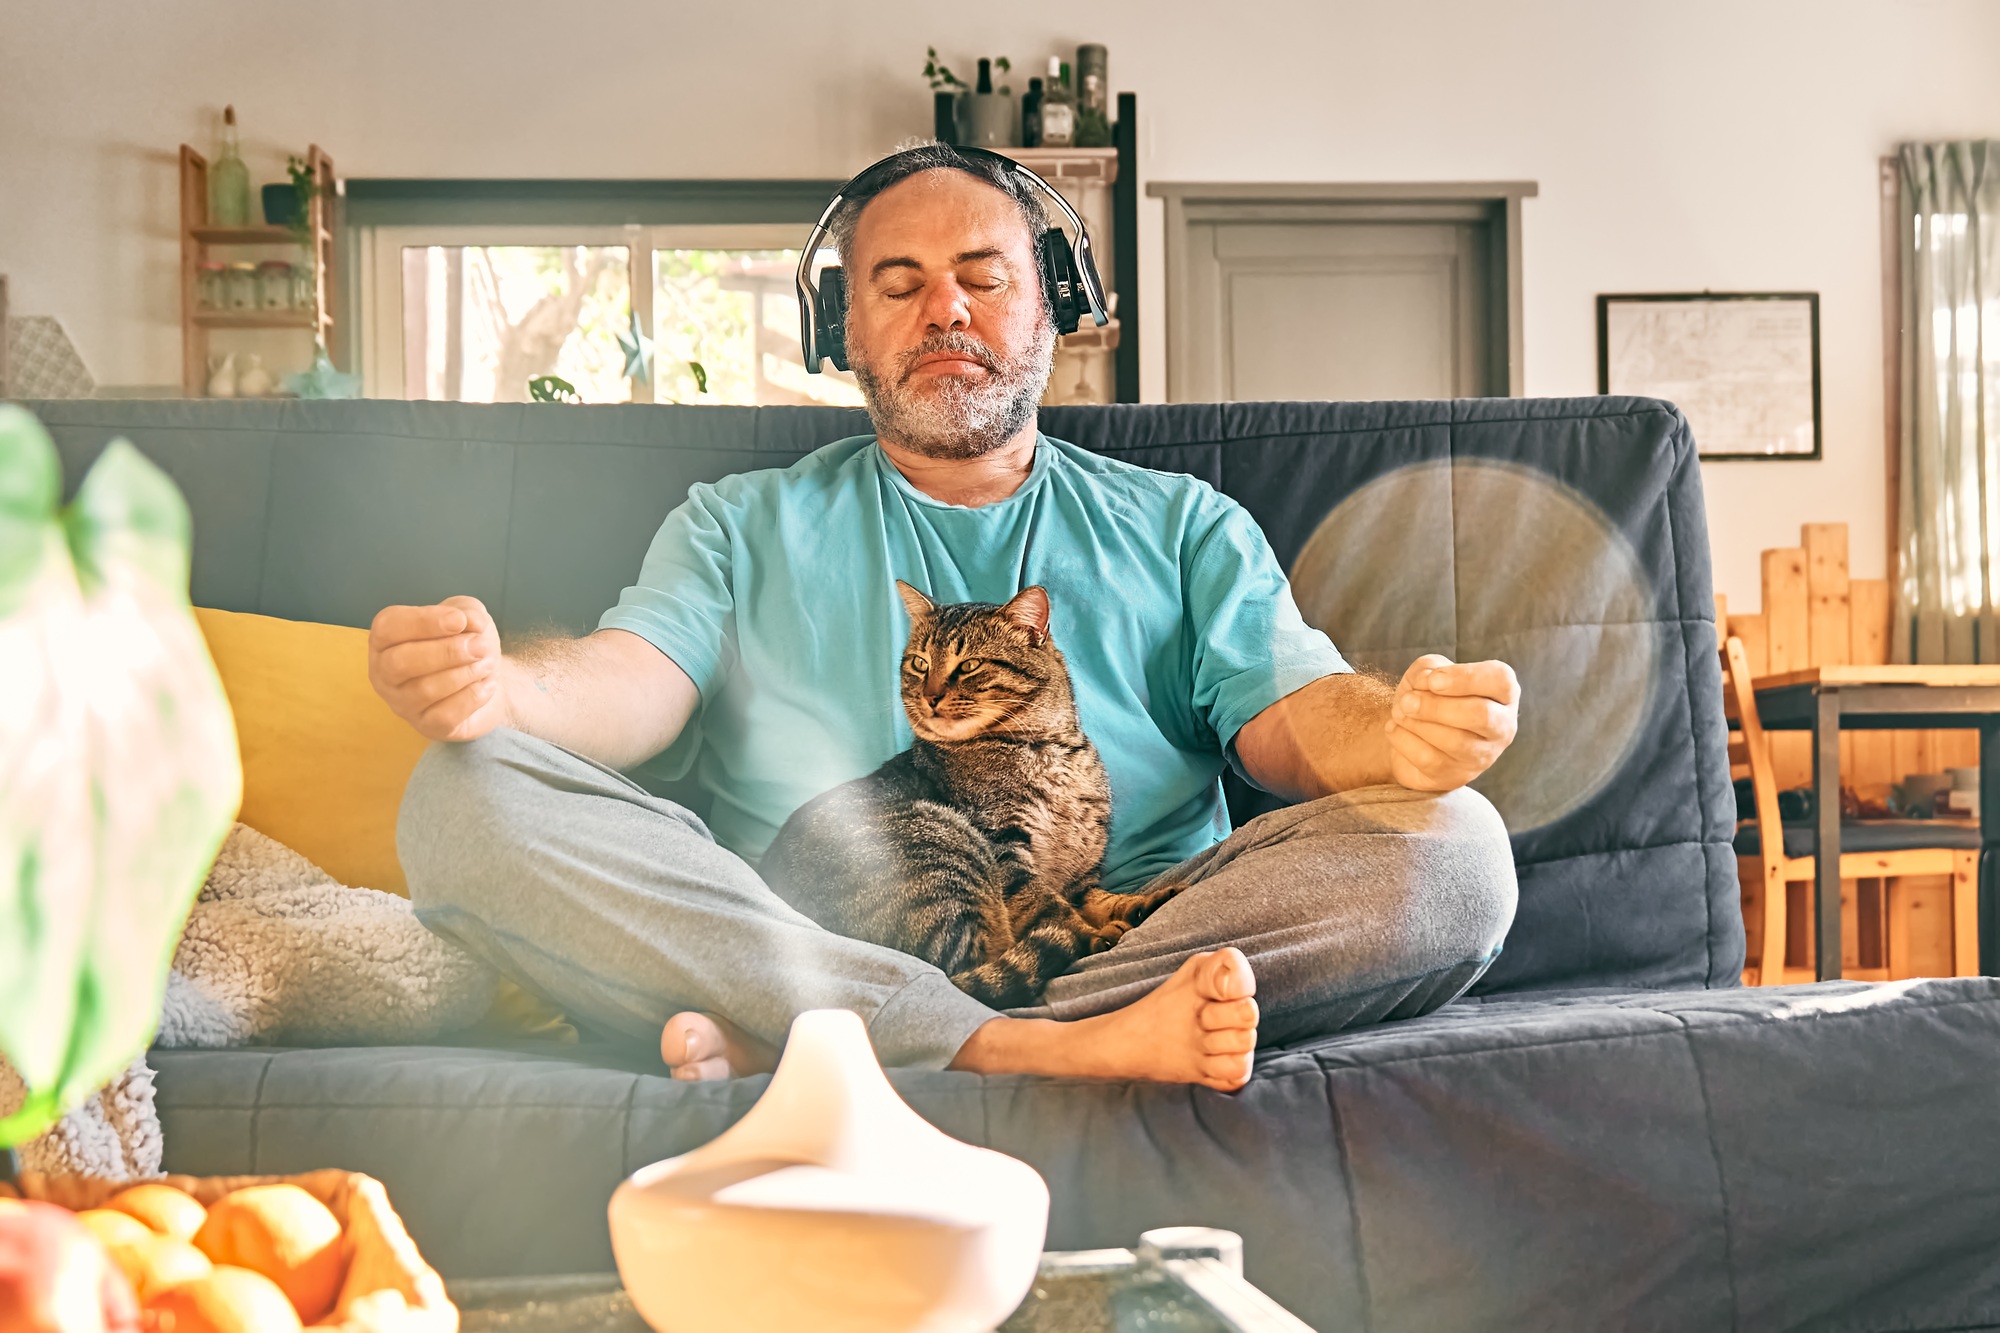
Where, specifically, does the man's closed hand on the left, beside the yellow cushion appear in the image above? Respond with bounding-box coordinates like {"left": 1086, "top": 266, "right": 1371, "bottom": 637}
{"left": 368, "top": 596, "right": 512, "bottom": 741}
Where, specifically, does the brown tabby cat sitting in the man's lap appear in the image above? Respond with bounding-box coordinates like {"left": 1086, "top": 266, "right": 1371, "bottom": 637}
{"left": 760, "top": 578, "right": 1172, "bottom": 1009}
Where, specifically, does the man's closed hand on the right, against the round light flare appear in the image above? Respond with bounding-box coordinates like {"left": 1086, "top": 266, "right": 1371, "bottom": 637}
{"left": 1386, "top": 652, "right": 1520, "bottom": 791}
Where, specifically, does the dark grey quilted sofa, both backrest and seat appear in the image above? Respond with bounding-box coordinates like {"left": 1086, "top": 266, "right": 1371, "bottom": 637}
{"left": 30, "top": 398, "right": 2000, "bottom": 1331}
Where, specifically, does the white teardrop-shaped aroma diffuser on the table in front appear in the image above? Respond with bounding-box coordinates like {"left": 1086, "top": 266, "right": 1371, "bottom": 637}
{"left": 610, "top": 1009, "right": 1048, "bottom": 1333}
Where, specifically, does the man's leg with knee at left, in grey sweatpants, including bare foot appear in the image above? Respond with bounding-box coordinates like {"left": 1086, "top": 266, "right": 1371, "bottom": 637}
{"left": 398, "top": 731, "right": 1256, "bottom": 1087}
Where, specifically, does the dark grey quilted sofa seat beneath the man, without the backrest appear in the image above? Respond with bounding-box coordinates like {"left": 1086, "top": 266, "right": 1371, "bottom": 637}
{"left": 152, "top": 977, "right": 2000, "bottom": 1333}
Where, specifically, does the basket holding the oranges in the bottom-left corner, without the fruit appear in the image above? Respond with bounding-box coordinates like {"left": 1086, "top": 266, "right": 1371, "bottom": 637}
{"left": 0, "top": 1171, "right": 458, "bottom": 1333}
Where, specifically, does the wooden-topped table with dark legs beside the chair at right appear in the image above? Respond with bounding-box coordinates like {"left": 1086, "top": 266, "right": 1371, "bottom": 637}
{"left": 1752, "top": 667, "right": 2000, "bottom": 981}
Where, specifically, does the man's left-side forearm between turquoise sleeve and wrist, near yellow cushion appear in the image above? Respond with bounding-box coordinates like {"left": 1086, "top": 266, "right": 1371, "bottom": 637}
{"left": 500, "top": 630, "right": 698, "bottom": 769}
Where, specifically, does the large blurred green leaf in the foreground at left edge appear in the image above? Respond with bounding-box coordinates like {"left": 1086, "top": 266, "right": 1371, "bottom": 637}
{"left": 0, "top": 404, "right": 242, "bottom": 1149}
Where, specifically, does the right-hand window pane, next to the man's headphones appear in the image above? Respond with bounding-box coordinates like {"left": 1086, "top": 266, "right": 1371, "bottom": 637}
{"left": 652, "top": 250, "right": 862, "bottom": 406}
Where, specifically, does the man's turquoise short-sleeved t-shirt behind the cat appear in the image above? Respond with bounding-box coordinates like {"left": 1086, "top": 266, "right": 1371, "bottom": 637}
{"left": 598, "top": 436, "right": 1348, "bottom": 891}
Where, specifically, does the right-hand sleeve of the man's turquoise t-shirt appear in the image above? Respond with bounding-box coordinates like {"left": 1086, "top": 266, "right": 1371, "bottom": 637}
{"left": 1184, "top": 496, "right": 1352, "bottom": 751}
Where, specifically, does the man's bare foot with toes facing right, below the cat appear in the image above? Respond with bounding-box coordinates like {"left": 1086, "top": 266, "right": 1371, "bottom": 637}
{"left": 952, "top": 949, "right": 1256, "bottom": 1093}
